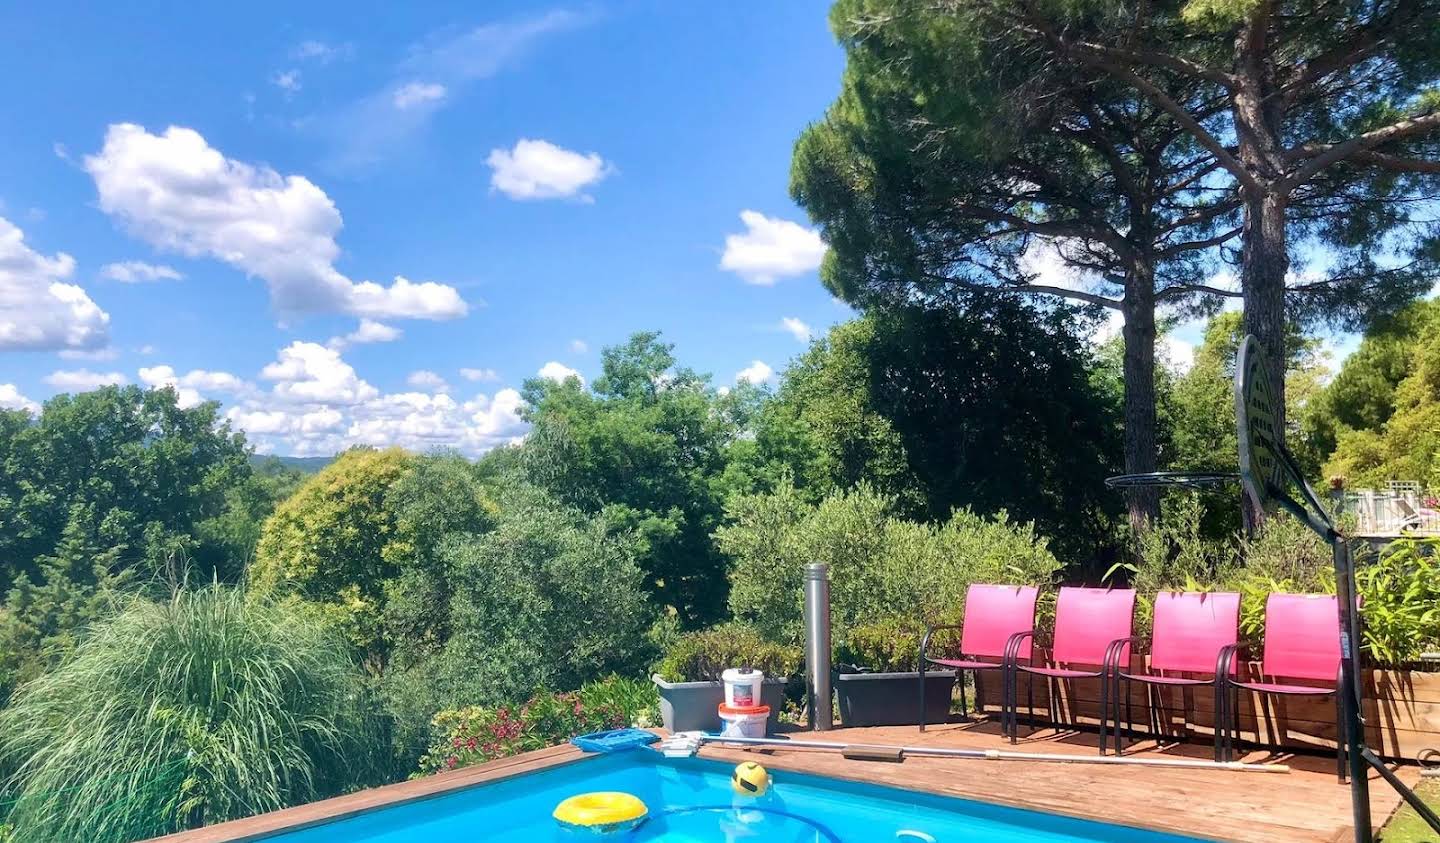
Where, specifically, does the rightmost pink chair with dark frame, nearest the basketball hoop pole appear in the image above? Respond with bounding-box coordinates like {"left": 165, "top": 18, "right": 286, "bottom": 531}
{"left": 1217, "top": 594, "right": 1345, "bottom": 782}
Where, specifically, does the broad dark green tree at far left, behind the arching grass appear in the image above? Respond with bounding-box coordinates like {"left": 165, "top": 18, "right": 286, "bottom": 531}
{"left": 0, "top": 386, "right": 251, "bottom": 589}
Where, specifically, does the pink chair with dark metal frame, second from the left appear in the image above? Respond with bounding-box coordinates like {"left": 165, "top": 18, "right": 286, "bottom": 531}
{"left": 1002, "top": 586, "right": 1135, "bottom": 755}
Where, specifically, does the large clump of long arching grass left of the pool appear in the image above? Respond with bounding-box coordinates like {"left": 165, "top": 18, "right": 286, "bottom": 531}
{"left": 0, "top": 586, "right": 384, "bottom": 843}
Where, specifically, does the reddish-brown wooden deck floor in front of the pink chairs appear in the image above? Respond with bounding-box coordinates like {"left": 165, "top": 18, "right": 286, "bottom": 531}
{"left": 701, "top": 722, "right": 1418, "bottom": 843}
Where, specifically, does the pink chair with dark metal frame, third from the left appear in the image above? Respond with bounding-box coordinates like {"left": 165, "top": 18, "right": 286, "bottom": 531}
{"left": 1102, "top": 591, "right": 1240, "bottom": 761}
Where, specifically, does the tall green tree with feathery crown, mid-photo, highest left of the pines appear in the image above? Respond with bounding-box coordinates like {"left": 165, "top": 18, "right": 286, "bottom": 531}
{"left": 523, "top": 333, "right": 740, "bottom": 627}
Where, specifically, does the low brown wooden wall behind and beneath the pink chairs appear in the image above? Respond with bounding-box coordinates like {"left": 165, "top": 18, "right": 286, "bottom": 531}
{"left": 976, "top": 657, "right": 1440, "bottom": 761}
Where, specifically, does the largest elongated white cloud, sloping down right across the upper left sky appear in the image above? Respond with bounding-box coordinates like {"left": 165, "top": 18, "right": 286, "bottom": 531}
{"left": 85, "top": 124, "right": 468, "bottom": 318}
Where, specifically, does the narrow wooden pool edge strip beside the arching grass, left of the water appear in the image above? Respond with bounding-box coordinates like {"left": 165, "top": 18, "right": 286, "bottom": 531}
{"left": 143, "top": 744, "right": 599, "bottom": 843}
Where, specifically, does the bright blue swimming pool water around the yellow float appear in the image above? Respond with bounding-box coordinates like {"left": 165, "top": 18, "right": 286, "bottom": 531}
{"left": 268, "top": 751, "right": 1197, "bottom": 843}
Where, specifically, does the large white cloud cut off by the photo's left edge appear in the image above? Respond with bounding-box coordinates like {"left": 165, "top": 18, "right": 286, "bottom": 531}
{"left": 0, "top": 216, "right": 109, "bottom": 352}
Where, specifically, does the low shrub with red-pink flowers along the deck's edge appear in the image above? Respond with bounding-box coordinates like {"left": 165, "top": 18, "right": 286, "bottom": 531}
{"left": 419, "top": 676, "right": 660, "bottom": 775}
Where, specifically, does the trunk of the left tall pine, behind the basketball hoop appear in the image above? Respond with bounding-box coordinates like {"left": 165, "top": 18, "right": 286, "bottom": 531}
{"left": 1120, "top": 261, "right": 1161, "bottom": 535}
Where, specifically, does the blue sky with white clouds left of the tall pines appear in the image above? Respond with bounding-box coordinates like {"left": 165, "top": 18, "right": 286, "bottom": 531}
{"left": 0, "top": 0, "right": 848, "bottom": 454}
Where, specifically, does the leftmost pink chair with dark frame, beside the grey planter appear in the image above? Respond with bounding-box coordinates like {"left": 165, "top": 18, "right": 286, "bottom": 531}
{"left": 920, "top": 584, "right": 1040, "bottom": 732}
